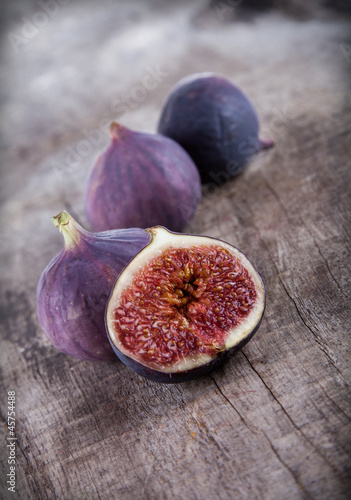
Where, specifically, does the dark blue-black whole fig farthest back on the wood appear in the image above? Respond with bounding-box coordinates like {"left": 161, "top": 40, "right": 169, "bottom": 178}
{"left": 158, "top": 73, "right": 273, "bottom": 184}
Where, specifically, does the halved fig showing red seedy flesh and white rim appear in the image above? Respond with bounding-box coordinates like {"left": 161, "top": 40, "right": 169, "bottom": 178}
{"left": 105, "top": 227, "right": 265, "bottom": 383}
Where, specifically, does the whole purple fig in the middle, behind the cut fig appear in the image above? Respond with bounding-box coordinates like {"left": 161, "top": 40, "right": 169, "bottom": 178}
{"left": 85, "top": 122, "right": 201, "bottom": 231}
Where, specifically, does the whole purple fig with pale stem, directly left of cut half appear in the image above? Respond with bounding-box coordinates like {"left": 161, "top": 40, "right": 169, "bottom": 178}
{"left": 37, "top": 212, "right": 150, "bottom": 361}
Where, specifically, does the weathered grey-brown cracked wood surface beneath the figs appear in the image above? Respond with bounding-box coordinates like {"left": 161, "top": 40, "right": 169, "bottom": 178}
{"left": 0, "top": 0, "right": 351, "bottom": 500}
